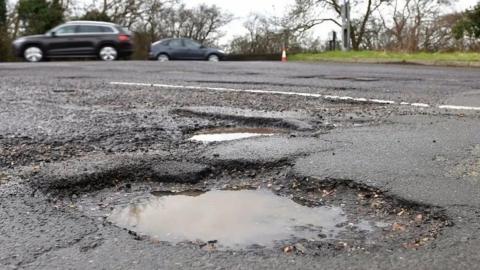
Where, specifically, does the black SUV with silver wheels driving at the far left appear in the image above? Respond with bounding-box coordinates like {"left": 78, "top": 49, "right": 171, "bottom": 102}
{"left": 13, "top": 21, "right": 133, "bottom": 62}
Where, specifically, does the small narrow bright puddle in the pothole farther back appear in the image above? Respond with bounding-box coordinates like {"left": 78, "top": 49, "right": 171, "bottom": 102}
{"left": 189, "top": 128, "right": 285, "bottom": 143}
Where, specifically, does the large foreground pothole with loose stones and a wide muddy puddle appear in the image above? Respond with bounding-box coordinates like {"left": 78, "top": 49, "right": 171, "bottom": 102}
{"left": 53, "top": 163, "right": 449, "bottom": 256}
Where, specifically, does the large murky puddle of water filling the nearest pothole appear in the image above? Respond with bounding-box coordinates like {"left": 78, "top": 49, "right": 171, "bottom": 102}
{"left": 109, "top": 190, "right": 352, "bottom": 248}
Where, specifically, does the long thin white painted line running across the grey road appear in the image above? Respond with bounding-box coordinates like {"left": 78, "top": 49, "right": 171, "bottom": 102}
{"left": 110, "top": 82, "right": 480, "bottom": 111}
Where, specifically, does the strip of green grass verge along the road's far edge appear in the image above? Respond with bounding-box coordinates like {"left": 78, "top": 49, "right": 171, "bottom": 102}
{"left": 289, "top": 51, "right": 480, "bottom": 64}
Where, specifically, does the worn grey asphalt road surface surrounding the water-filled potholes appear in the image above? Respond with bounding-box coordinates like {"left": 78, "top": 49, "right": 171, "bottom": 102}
{"left": 0, "top": 61, "right": 480, "bottom": 269}
